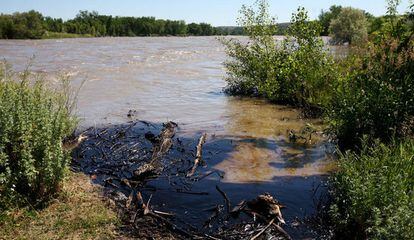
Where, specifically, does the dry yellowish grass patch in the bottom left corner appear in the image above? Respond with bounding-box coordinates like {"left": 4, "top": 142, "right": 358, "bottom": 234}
{"left": 0, "top": 172, "right": 120, "bottom": 239}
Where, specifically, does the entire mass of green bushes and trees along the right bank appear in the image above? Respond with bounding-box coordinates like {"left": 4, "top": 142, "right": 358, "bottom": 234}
{"left": 222, "top": 0, "right": 414, "bottom": 239}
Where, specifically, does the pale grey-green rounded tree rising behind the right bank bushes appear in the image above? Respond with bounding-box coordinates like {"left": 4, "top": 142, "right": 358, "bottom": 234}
{"left": 329, "top": 7, "right": 368, "bottom": 44}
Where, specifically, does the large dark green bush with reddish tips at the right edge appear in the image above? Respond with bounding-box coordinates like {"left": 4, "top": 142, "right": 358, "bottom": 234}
{"left": 328, "top": 2, "right": 414, "bottom": 147}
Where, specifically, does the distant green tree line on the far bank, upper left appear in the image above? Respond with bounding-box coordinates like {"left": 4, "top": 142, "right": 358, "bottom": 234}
{"left": 0, "top": 10, "right": 233, "bottom": 39}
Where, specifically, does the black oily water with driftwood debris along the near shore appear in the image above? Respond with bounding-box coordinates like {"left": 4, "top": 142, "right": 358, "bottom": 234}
{"left": 74, "top": 118, "right": 334, "bottom": 239}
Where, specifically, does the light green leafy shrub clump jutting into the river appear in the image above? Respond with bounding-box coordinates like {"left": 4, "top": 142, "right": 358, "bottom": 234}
{"left": 221, "top": 0, "right": 335, "bottom": 111}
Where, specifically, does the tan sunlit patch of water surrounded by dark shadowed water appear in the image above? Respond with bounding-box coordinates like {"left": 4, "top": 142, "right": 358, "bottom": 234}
{"left": 213, "top": 140, "right": 336, "bottom": 183}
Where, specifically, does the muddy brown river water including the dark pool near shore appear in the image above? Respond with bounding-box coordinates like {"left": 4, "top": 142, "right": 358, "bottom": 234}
{"left": 0, "top": 37, "right": 334, "bottom": 239}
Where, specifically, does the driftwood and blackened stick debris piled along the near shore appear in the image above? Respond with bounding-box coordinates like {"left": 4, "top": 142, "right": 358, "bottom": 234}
{"left": 73, "top": 121, "right": 291, "bottom": 239}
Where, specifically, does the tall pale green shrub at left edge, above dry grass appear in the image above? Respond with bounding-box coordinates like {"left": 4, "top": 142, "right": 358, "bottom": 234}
{"left": 0, "top": 63, "right": 76, "bottom": 207}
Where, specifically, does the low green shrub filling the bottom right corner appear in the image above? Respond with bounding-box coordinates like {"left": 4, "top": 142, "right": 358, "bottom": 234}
{"left": 330, "top": 139, "right": 414, "bottom": 239}
